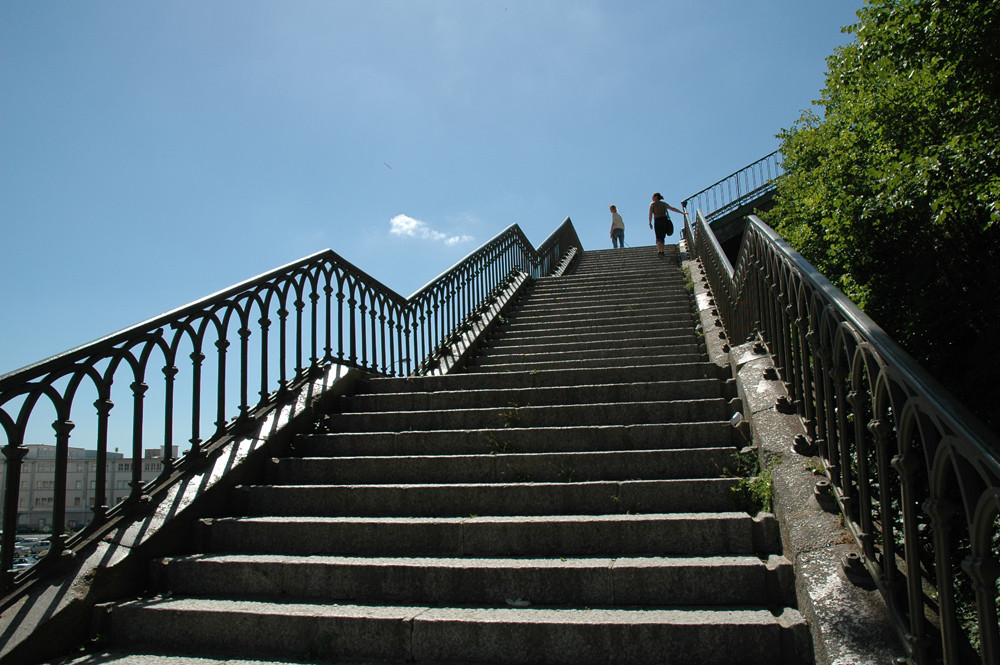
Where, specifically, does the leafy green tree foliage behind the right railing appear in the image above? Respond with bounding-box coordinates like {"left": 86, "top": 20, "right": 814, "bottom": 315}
{"left": 767, "top": 0, "right": 1000, "bottom": 428}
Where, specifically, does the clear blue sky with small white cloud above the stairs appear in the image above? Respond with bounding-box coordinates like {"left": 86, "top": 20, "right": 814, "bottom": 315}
{"left": 0, "top": 0, "right": 862, "bottom": 373}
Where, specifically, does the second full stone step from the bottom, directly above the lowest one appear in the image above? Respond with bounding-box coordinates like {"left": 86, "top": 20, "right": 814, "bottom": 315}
{"left": 151, "top": 554, "right": 794, "bottom": 607}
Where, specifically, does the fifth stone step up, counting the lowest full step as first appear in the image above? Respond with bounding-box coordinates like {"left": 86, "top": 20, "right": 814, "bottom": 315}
{"left": 268, "top": 447, "right": 736, "bottom": 485}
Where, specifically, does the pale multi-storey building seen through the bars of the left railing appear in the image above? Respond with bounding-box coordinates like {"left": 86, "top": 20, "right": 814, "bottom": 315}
{"left": 0, "top": 444, "right": 174, "bottom": 531}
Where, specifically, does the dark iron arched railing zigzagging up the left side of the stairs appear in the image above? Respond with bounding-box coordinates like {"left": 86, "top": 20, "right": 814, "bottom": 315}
{"left": 0, "top": 218, "right": 580, "bottom": 591}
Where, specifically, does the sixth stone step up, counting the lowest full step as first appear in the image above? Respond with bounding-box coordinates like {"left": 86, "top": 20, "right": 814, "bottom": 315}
{"left": 295, "top": 420, "right": 745, "bottom": 457}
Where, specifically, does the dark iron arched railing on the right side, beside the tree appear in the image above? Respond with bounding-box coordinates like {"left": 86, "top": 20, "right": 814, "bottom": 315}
{"left": 685, "top": 211, "right": 1000, "bottom": 665}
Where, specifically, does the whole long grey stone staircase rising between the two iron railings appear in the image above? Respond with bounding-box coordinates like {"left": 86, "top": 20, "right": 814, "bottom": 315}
{"left": 80, "top": 247, "right": 811, "bottom": 664}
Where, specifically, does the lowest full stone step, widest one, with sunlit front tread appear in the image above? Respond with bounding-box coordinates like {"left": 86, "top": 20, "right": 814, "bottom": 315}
{"left": 99, "top": 598, "right": 805, "bottom": 665}
